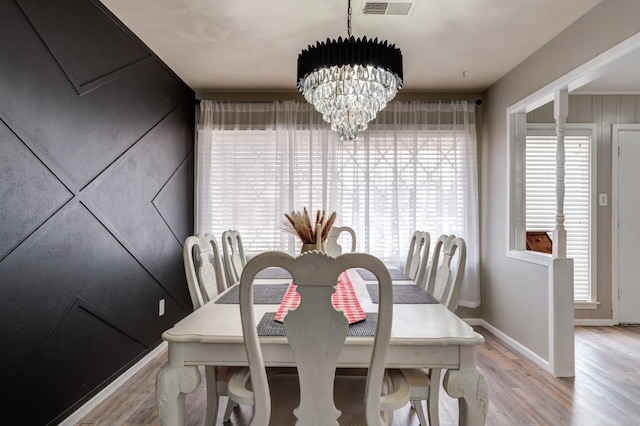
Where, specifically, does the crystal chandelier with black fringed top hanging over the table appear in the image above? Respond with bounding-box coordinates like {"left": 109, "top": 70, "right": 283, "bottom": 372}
{"left": 297, "top": 0, "right": 402, "bottom": 141}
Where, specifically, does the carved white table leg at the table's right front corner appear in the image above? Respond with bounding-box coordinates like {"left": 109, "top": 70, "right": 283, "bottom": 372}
{"left": 444, "top": 346, "right": 489, "bottom": 426}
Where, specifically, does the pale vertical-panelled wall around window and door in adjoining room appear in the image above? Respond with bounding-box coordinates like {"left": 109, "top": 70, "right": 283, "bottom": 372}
{"left": 527, "top": 95, "right": 640, "bottom": 320}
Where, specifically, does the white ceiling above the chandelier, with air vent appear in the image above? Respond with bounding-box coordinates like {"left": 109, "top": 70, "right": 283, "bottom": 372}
{"left": 97, "top": 0, "right": 640, "bottom": 93}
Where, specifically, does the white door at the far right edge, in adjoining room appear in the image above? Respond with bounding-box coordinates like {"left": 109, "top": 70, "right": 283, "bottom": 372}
{"left": 612, "top": 125, "right": 640, "bottom": 324}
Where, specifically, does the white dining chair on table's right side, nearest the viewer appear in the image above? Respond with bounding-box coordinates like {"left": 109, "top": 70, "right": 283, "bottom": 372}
{"left": 401, "top": 235, "right": 467, "bottom": 426}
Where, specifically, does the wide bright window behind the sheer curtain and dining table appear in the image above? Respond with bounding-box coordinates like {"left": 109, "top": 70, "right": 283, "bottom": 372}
{"left": 200, "top": 129, "right": 470, "bottom": 265}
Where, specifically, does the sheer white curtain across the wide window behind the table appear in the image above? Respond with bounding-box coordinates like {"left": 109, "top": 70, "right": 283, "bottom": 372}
{"left": 196, "top": 101, "right": 480, "bottom": 307}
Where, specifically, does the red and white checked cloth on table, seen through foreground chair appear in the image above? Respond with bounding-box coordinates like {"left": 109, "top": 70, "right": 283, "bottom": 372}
{"left": 274, "top": 272, "right": 367, "bottom": 324}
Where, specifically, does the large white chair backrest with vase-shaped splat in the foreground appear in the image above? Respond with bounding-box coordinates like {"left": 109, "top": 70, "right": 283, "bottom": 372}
{"left": 240, "top": 251, "right": 393, "bottom": 426}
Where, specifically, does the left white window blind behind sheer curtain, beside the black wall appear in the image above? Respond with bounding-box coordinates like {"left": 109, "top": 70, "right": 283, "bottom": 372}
{"left": 199, "top": 129, "right": 329, "bottom": 256}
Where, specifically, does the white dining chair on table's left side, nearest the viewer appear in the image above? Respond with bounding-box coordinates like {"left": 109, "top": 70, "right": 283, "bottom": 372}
{"left": 182, "top": 233, "right": 240, "bottom": 425}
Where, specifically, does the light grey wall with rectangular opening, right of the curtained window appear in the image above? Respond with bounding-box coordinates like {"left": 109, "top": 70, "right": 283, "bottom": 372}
{"left": 479, "top": 0, "right": 640, "bottom": 360}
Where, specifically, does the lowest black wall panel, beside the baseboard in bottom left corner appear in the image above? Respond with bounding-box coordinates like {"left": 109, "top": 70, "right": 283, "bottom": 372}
{"left": 3, "top": 300, "right": 144, "bottom": 425}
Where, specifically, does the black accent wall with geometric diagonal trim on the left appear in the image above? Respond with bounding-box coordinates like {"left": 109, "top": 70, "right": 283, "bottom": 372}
{"left": 0, "top": 0, "right": 194, "bottom": 425}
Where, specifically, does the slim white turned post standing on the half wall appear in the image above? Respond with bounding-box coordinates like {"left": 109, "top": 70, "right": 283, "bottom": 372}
{"left": 553, "top": 89, "right": 569, "bottom": 259}
